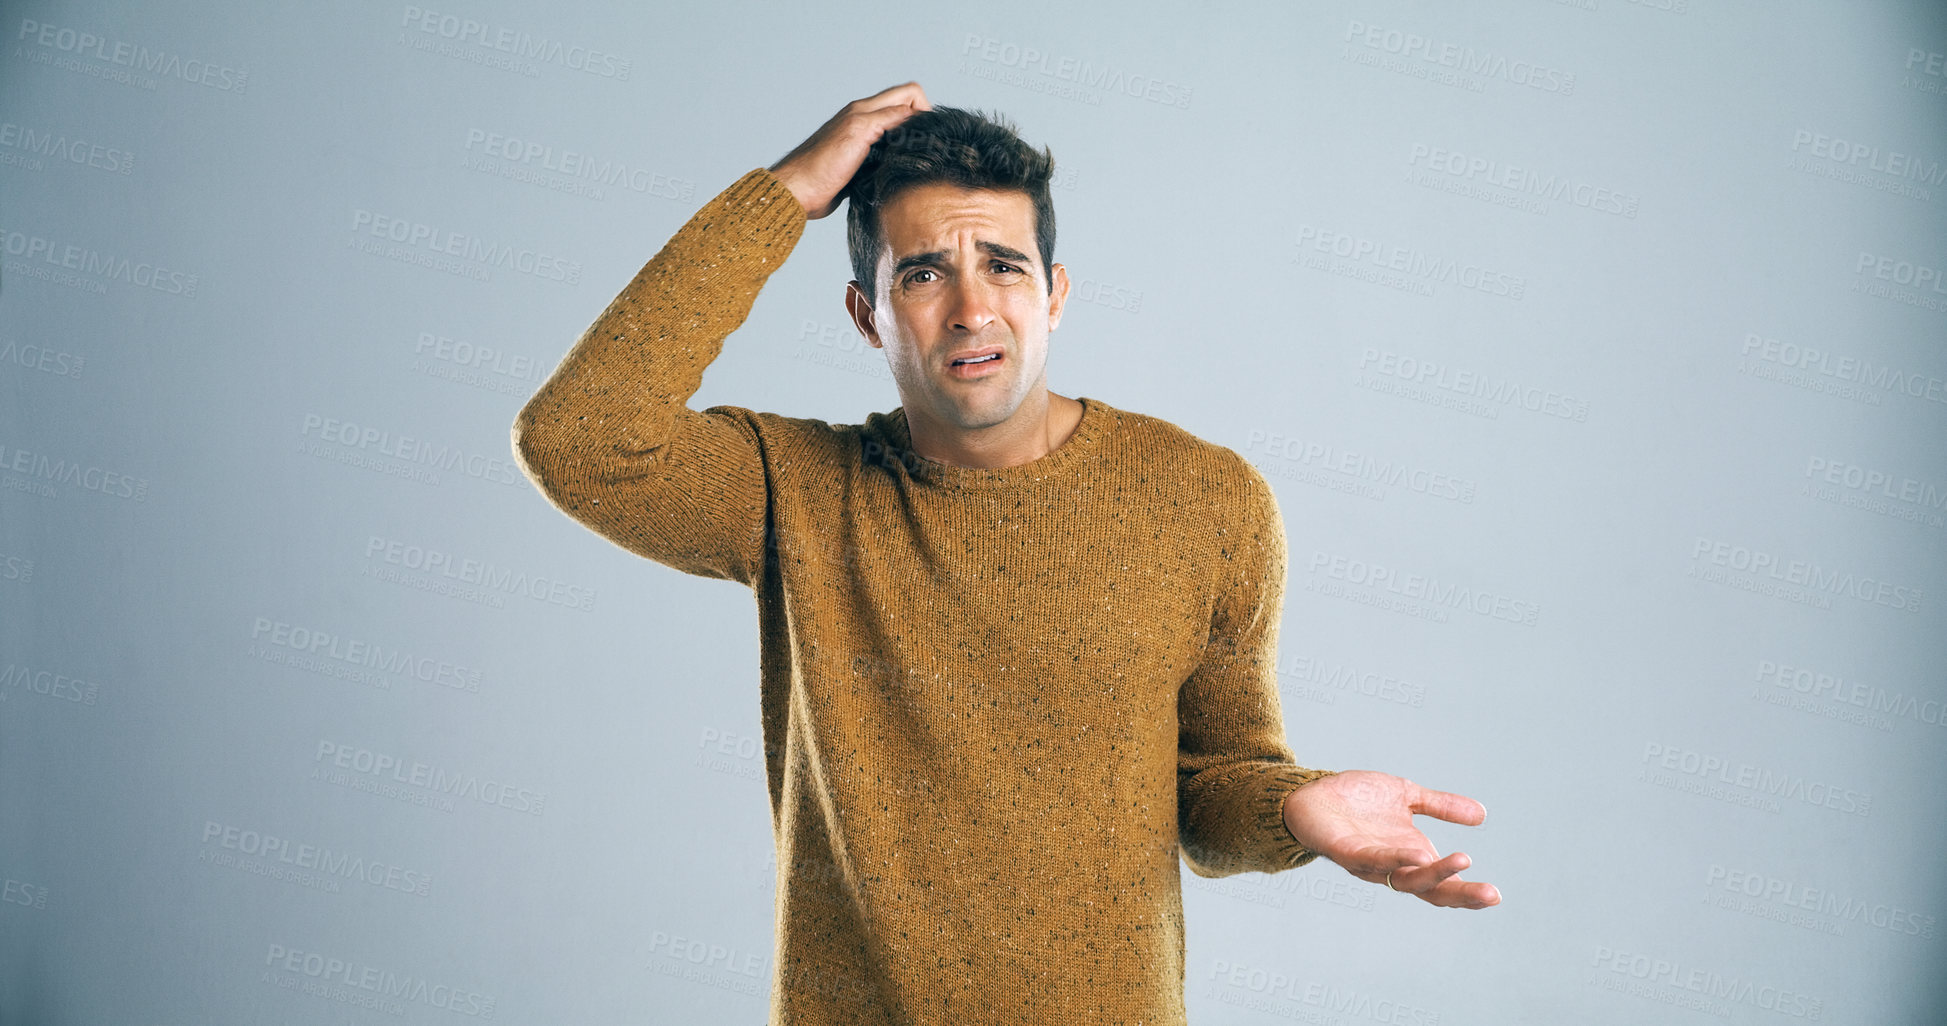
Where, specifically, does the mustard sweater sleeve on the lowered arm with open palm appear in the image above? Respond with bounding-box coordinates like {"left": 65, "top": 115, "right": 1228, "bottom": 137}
{"left": 1176, "top": 458, "right": 1334, "bottom": 876}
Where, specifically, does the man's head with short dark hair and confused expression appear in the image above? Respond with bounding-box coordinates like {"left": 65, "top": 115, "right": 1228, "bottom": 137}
{"left": 845, "top": 107, "right": 1067, "bottom": 441}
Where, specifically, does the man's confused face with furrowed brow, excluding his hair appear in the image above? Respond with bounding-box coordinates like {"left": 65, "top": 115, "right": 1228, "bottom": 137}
{"left": 845, "top": 183, "right": 1069, "bottom": 430}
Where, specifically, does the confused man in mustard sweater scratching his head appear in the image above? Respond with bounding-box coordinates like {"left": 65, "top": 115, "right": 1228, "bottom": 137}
{"left": 514, "top": 82, "right": 1499, "bottom": 1024}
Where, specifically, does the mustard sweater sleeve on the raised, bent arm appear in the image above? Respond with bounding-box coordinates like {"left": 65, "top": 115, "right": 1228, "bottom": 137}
{"left": 512, "top": 167, "right": 806, "bottom": 584}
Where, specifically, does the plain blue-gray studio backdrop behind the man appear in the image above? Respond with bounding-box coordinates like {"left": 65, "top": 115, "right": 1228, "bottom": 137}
{"left": 0, "top": 0, "right": 1947, "bottom": 1026}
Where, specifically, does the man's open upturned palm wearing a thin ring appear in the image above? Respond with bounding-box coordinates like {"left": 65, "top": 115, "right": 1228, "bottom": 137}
{"left": 1285, "top": 769, "right": 1501, "bottom": 909}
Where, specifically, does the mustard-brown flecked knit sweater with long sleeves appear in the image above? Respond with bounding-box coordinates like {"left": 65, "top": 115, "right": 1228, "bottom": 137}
{"left": 514, "top": 169, "right": 1328, "bottom": 1026}
